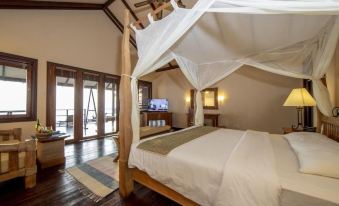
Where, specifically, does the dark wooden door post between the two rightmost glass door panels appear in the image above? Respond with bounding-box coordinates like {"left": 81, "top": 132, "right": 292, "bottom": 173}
{"left": 97, "top": 74, "right": 105, "bottom": 137}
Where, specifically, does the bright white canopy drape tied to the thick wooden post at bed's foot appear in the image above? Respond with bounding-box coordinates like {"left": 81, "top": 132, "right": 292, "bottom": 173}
{"left": 131, "top": 0, "right": 214, "bottom": 142}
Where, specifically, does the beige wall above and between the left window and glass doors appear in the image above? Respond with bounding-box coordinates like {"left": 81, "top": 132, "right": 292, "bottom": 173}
{"left": 0, "top": 10, "right": 135, "bottom": 138}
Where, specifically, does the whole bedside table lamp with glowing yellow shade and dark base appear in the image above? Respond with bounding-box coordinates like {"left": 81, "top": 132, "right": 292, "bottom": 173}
{"left": 283, "top": 88, "right": 316, "bottom": 130}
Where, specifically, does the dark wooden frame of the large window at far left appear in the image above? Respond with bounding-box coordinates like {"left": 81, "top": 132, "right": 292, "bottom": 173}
{"left": 0, "top": 52, "right": 38, "bottom": 123}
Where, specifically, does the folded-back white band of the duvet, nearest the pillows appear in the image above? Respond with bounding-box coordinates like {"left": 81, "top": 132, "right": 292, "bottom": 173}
{"left": 214, "top": 130, "right": 280, "bottom": 206}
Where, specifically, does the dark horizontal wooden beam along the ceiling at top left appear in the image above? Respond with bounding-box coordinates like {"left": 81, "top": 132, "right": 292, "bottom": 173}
{"left": 0, "top": 0, "right": 104, "bottom": 10}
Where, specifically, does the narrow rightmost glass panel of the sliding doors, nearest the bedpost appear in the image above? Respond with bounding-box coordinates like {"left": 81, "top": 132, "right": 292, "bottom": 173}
{"left": 105, "top": 78, "right": 118, "bottom": 134}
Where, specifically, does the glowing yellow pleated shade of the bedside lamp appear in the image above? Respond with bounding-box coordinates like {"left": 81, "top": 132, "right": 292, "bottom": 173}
{"left": 284, "top": 88, "right": 316, "bottom": 107}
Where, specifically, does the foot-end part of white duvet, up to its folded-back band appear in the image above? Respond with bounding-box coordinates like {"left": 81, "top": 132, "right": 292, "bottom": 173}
{"left": 129, "top": 128, "right": 244, "bottom": 205}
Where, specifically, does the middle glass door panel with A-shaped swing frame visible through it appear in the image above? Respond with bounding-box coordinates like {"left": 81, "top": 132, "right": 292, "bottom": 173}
{"left": 83, "top": 73, "right": 99, "bottom": 137}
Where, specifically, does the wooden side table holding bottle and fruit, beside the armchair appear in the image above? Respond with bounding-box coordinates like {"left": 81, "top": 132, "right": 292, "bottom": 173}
{"left": 37, "top": 135, "right": 69, "bottom": 169}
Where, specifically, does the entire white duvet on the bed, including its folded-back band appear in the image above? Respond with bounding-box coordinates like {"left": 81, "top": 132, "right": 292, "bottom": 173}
{"left": 129, "top": 129, "right": 280, "bottom": 206}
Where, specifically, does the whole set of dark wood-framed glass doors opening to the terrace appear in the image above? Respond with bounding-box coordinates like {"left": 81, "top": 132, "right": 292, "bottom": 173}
{"left": 46, "top": 62, "right": 120, "bottom": 143}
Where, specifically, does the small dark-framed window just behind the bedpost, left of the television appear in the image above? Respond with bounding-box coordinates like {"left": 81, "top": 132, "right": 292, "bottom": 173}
{"left": 138, "top": 80, "right": 152, "bottom": 111}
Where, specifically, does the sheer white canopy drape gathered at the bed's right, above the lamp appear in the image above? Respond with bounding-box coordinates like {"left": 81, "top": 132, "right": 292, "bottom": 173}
{"left": 242, "top": 16, "right": 339, "bottom": 116}
